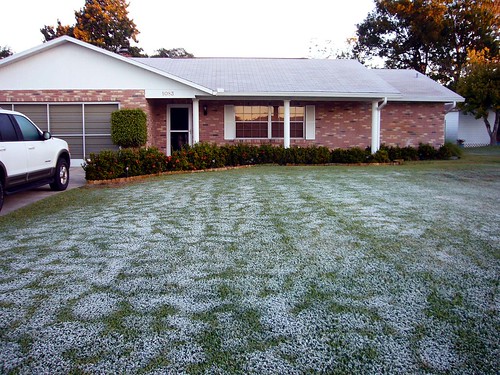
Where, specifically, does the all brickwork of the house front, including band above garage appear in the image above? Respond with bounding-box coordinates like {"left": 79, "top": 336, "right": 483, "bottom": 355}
{"left": 0, "top": 90, "right": 444, "bottom": 152}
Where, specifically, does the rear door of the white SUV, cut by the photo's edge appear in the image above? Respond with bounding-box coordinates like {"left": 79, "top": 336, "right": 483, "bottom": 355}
{"left": 0, "top": 113, "right": 28, "bottom": 189}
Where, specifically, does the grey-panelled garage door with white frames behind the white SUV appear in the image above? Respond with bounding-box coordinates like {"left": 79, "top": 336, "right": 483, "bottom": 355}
{"left": 0, "top": 103, "right": 119, "bottom": 165}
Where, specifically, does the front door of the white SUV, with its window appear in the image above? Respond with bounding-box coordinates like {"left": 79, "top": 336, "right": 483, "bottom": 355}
{"left": 14, "top": 115, "right": 55, "bottom": 181}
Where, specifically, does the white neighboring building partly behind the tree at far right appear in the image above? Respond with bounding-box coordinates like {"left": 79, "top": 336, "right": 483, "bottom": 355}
{"left": 445, "top": 110, "right": 495, "bottom": 147}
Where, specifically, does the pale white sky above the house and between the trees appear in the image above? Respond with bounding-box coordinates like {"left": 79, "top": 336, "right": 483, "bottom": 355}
{"left": 0, "top": 0, "right": 374, "bottom": 57}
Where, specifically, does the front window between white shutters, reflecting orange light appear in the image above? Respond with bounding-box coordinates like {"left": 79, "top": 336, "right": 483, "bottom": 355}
{"left": 234, "top": 106, "right": 305, "bottom": 138}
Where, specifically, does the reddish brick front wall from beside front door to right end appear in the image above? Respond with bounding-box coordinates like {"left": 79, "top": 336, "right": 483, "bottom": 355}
{"left": 145, "top": 100, "right": 444, "bottom": 151}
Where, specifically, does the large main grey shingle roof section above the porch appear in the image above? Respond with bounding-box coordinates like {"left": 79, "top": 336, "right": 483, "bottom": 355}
{"left": 134, "top": 58, "right": 400, "bottom": 98}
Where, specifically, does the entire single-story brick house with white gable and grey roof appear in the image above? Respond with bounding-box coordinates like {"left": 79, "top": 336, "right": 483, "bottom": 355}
{"left": 0, "top": 36, "right": 463, "bottom": 164}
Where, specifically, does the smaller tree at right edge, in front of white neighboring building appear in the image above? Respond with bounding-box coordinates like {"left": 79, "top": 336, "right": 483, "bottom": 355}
{"left": 457, "top": 51, "right": 500, "bottom": 145}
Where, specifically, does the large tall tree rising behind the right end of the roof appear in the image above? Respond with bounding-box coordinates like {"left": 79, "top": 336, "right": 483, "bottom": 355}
{"left": 354, "top": 0, "right": 500, "bottom": 87}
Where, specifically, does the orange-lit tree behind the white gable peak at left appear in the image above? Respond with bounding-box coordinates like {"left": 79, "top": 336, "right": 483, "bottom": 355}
{"left": 40, "top": 0, "right": 141, "bottom": 55}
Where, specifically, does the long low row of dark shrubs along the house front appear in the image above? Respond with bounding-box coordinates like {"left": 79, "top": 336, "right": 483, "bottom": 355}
{"left": 83, "top": 143, "right": 461, "bottom": 180}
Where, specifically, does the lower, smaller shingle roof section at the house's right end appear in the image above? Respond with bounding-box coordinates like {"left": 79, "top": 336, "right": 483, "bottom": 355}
{"left": 372, "top": 69, "right": 464, "bottom": 102}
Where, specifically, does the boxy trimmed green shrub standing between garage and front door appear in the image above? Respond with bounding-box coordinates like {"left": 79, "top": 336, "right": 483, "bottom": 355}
{"left": 111, "top": 109, "right": 148, "bottom": 148}
